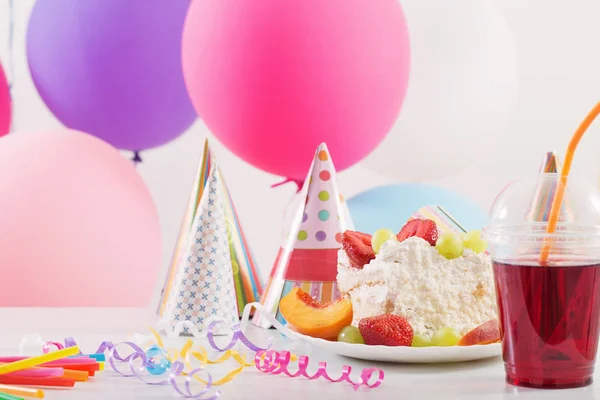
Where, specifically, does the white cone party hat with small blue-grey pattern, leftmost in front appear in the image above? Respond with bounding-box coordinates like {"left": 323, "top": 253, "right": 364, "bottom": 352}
{"left": 160, "top": 160, "right": 244, "bottom": 334}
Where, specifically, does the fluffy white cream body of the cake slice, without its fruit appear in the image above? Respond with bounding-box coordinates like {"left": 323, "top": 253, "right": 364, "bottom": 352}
{"left": 337, "top": 237, "right": 497, "bottom": 337}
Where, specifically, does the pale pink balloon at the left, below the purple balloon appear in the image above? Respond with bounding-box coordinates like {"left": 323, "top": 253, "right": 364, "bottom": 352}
{"left": 0, "top": 131, "right": 162, "bottom": 307}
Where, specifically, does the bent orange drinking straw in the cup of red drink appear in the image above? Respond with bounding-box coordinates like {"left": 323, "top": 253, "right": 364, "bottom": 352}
{"left": 539, "top": 103, "right": 600, "bottom": 265}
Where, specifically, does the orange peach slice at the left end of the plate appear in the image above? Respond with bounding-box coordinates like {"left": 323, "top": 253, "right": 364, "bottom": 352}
{"left": 279, "top": 288, "right": 352, "bottom": 340}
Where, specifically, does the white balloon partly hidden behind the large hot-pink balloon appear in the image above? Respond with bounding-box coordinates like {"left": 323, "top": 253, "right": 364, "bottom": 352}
{"left": 364, "top": 0, "right": 519, "bottom": 181}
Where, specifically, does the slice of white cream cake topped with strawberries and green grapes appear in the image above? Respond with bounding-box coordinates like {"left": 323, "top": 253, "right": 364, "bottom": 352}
{"left": 337, "top": 219, "right": 498, "bottom": 339}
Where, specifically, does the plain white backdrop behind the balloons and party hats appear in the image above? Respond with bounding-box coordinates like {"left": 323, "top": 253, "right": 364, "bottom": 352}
{"left": 0, "top": 0, "right": 600, "bottom": 310}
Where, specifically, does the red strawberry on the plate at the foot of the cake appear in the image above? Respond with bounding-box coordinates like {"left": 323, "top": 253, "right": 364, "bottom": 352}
{"left": 358, "top": 314, "right": 414, "bottom": 346}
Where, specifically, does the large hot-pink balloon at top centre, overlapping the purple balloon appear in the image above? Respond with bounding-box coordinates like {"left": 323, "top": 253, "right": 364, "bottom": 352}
{"left": 183, "top": 0, "right": 409, "bottom": 179}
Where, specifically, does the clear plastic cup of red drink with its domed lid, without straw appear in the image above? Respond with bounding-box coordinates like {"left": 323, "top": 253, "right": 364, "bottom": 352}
{"left": 484, "top": 174, "right": 600, "bottom": 388}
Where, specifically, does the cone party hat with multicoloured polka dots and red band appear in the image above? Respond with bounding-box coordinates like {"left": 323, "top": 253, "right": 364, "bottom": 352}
{"left": 252, "top": 143, "right": 354, "bottom": 328}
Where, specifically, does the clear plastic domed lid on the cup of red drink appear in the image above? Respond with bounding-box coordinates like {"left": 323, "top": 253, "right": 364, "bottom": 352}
{"left": 484, "top": 173, "right": 600, "bottom": 249}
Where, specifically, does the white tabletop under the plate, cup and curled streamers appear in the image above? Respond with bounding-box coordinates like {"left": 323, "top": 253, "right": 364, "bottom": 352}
{"left": 0, "top": 309, "right": 600, "bottom": 400}
